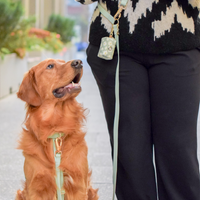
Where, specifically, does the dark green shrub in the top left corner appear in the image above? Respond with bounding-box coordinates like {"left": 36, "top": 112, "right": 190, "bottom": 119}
{"left": 0, "top": 0, "right": 23, "bottom": 51}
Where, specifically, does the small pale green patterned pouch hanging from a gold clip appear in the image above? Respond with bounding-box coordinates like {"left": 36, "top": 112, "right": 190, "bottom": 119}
{"left": 98, "top": 37, "right": 116, "bottom": 60}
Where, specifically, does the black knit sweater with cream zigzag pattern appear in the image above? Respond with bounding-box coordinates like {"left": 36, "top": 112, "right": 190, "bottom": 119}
{"left": 76, "top": 0, "right": 200, "bottom": 54}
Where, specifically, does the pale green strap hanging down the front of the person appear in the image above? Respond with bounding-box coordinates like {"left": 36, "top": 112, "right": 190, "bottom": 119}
{"left": 98, "top": 0, "right": 128, "bottom": 200}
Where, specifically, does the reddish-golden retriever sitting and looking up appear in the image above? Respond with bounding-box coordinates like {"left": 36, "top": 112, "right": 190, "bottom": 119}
{"left": 16, "top": 59, "right": 98, "bottom": 200}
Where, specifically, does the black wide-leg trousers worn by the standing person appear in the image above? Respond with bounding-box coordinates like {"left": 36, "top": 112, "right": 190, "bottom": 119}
{"left": 87, "top": 45, "right": 200, "bottom": 200}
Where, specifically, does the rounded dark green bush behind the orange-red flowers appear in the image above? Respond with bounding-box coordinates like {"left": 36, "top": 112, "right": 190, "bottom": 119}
{"left": 46, "top": 14, "right": 75, "bottom": 43}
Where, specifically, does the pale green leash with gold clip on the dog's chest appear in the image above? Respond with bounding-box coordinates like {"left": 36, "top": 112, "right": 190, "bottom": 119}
{"left": 48, "top": 133, "right": 65, "bottom": 200}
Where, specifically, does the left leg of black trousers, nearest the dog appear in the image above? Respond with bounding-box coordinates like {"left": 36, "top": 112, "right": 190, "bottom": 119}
{"left": 87, "top": 45, "right": 157, "bottom": 200}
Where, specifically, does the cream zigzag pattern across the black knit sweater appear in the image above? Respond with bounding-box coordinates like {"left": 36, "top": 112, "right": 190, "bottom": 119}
{"left": 92, "top": 0, "right": 200, "bottom": 40}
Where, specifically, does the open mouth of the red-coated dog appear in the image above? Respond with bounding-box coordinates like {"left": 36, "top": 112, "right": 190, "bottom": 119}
{"left": 53, "top": 73, "right": 81, "bottom": 98}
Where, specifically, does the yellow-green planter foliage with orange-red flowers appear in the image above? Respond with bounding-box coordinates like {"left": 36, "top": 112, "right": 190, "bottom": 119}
{"left": 1, "top": 17, "right": 63, "bottom": 58}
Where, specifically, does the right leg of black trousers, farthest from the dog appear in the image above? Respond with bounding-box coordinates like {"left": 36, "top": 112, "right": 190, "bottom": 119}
{"left": 149, "top": 49, "right": 200, "bottom": 200}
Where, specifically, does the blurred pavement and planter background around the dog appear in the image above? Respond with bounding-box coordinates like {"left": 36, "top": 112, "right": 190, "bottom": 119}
{"left": 0, "top": 0, "right": 112, "bottom": 200}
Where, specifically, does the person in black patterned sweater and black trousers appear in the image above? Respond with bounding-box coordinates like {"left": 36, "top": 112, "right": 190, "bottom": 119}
{"left": 76, "top": 0, "right": 200, "bottom": 200}
